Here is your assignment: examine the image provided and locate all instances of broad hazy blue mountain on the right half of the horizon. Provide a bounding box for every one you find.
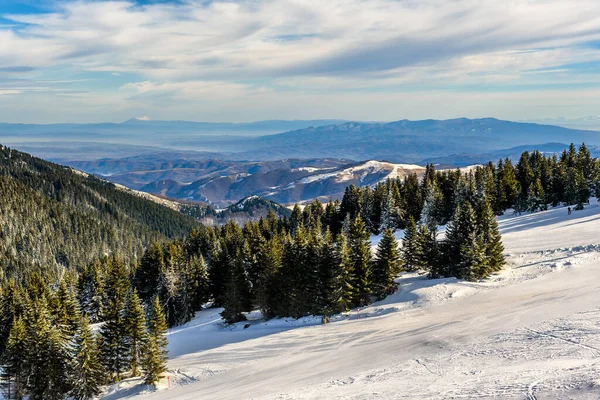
[237,118,600,163]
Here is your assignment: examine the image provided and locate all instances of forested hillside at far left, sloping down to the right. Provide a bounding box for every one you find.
[0,146,197,271]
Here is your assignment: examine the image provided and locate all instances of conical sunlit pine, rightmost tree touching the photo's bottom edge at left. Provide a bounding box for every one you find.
[71,316,105,400]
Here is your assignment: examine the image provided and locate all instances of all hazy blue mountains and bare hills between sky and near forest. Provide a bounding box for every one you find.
[0,117,600,208]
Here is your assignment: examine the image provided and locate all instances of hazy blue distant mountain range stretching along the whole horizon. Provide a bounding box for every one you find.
[0,118,600,163]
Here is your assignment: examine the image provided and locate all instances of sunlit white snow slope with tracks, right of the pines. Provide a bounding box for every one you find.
[104,200,600,400]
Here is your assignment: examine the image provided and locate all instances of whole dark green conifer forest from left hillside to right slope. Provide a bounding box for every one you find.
[0,145,600,399]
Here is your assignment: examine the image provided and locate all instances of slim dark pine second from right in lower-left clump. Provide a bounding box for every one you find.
[123,289,147,376]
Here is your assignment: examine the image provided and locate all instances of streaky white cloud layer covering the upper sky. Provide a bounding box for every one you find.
[0,0,600,119]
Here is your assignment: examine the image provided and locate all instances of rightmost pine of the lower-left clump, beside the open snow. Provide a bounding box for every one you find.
[142,297,168,386]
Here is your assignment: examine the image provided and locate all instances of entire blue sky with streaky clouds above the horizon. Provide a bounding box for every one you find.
[0,0,600,123]
